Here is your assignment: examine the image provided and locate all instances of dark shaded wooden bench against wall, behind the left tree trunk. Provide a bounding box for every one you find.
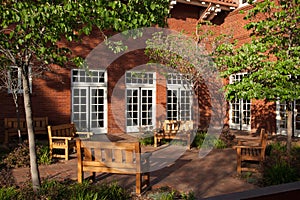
[4,117,48,144]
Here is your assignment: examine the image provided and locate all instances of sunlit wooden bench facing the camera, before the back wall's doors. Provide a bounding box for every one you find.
[154,120,194,149]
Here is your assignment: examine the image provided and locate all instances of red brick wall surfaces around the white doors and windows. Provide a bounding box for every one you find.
[0,3,276,141]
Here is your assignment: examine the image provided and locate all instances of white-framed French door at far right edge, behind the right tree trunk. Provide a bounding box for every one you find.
[276,100,300,137]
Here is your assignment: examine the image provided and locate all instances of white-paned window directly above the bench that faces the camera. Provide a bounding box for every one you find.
[167,73,193,121]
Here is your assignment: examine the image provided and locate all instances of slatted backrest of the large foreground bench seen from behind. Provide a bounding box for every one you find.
[76,139,141,174]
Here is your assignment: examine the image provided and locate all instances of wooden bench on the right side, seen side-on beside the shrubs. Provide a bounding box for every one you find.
[234,129,268,174]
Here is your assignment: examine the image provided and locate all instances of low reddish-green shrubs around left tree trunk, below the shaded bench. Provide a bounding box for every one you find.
[3,141,51,168]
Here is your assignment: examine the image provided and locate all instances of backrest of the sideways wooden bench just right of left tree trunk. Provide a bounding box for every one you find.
[48,124,76,137]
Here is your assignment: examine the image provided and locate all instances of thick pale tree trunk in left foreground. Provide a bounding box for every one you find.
[21,68,41,192]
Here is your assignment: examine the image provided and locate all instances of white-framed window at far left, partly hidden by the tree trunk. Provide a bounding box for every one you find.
[7,66,32,94]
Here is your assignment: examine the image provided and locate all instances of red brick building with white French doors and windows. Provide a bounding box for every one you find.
[0,0,300,141]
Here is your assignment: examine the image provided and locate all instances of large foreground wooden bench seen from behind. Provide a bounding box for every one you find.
[76,139,151,194]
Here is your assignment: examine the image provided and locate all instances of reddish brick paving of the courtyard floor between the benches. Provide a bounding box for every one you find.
[12,148,256,199]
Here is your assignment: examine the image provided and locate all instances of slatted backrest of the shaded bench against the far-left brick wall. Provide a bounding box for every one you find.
[4,117,48,130]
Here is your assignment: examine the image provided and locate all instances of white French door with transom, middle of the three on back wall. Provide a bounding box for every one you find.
[125,71,156,132]
